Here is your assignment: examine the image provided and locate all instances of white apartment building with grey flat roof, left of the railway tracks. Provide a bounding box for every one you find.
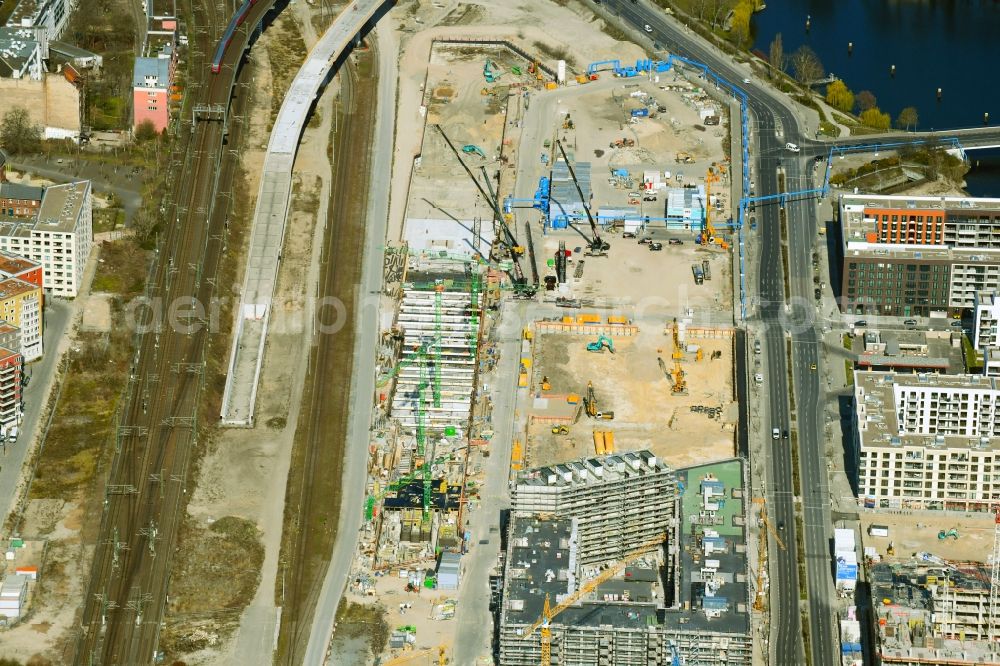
[0,181,94,298]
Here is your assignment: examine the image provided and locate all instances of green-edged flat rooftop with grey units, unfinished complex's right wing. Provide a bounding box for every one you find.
[664,460,750,634]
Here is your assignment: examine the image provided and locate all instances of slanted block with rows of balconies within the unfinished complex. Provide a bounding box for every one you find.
[512,451,677,564]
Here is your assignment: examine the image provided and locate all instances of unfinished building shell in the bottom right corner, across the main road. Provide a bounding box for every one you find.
[868,553,1000,666]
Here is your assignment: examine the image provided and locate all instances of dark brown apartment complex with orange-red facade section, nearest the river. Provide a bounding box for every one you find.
[840,194,1000,316]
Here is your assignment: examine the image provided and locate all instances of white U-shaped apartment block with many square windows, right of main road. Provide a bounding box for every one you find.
[854,371,1000,511]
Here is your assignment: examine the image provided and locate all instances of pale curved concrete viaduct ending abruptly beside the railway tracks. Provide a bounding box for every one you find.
[220,0,391,426]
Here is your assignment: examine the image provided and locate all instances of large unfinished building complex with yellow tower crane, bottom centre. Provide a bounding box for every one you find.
[497,451,751,666]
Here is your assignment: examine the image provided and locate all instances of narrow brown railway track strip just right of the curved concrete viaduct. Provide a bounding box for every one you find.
[278,45,376,664]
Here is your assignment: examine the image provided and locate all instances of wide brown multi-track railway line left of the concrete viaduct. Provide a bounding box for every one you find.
[74,1,272,665]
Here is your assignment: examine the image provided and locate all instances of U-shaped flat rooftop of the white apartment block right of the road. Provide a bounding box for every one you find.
[854,372,1000,450]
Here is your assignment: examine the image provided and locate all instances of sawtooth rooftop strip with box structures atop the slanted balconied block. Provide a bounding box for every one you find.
[516,451,670,488]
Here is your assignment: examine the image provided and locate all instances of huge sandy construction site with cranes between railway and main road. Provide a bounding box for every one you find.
[348,22,750,664]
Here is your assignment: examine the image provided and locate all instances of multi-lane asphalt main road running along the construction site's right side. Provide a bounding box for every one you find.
[608,1,839,666]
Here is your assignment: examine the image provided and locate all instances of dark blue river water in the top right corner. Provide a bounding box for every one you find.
[753,0,1000,196]
